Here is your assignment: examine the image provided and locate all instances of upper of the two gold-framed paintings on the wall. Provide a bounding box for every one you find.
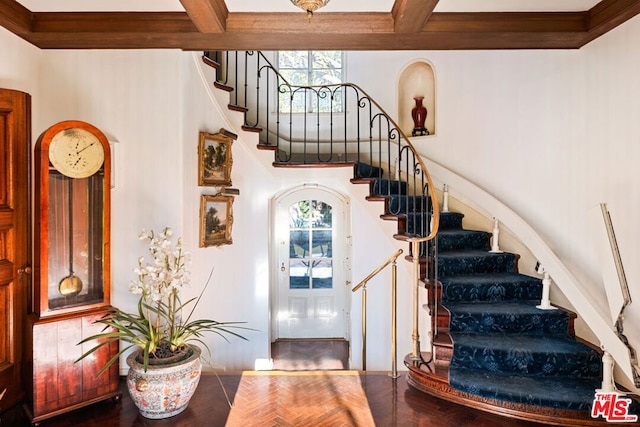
[198,129,237,187]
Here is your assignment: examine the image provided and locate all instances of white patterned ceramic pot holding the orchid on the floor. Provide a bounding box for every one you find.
[127,345,202,419]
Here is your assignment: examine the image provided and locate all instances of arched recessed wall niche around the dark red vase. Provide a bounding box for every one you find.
[398,60,436,136]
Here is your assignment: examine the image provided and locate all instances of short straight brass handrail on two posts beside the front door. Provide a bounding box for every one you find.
[351,249,402,378]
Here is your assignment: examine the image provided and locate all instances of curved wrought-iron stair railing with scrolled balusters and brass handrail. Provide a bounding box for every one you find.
[202,51,440,360]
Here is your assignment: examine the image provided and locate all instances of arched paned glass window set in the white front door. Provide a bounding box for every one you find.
[289,200,333,289]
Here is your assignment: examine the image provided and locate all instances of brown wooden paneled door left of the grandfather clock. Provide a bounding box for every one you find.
[0,89,31,409]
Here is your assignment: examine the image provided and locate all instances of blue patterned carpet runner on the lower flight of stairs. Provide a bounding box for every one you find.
[438,213,602,411]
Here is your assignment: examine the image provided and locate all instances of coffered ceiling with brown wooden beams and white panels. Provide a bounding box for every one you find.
[0,0,640,50]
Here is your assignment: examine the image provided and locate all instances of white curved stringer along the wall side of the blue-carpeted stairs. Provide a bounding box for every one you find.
[423,157,640,394]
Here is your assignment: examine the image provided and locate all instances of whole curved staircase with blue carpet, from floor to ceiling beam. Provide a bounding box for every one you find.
[198,53,637,426]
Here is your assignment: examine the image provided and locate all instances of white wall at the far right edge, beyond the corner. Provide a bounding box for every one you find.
[588,17,640,362]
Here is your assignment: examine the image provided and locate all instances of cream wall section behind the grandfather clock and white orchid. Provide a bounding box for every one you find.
[33,51,184,318]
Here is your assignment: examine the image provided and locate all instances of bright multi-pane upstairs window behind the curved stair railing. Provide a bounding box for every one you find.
[278,50,344,113]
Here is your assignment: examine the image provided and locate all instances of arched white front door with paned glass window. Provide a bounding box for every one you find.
[273,187,350,338]
